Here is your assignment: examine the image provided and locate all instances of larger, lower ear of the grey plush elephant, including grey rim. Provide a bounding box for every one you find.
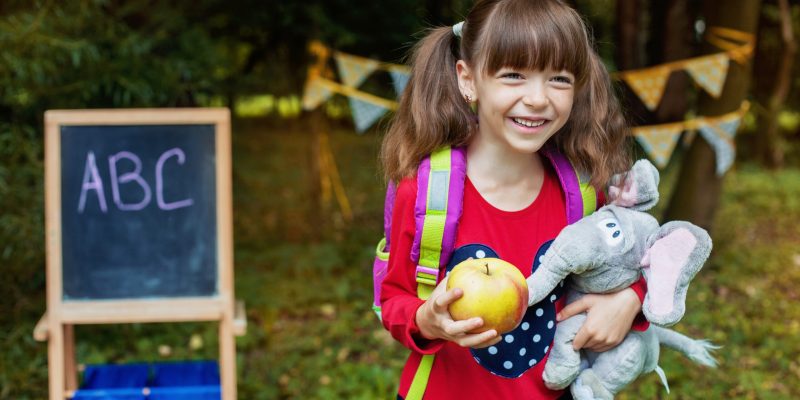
[641,221,711,326]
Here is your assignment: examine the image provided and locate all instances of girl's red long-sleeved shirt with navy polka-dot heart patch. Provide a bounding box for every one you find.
[381,165,643,400]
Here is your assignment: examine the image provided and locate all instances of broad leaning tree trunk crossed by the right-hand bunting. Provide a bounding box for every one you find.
[665,0,761,230]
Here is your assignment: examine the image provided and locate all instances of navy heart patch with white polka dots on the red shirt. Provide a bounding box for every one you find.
[447,240,564,378]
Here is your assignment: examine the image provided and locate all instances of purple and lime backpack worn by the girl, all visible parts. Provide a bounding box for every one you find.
[372,146,597,400]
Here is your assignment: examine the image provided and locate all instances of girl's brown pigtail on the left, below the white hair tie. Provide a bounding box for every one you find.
[380,27,475,182]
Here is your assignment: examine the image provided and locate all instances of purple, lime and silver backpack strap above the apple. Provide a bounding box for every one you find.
[411,147,467,300]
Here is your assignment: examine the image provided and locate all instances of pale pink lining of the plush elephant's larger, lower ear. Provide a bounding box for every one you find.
[642,228,697,315]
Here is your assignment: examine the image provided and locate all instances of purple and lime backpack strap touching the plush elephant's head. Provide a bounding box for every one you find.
[541,146,597,224]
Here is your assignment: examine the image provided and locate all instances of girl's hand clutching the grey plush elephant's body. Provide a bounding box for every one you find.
[556,288,642,352]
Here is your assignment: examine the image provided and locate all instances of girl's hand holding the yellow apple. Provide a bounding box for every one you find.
[416,278,501,348]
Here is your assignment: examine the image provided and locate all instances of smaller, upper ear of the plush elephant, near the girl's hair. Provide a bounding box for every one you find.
[608,159,659,211]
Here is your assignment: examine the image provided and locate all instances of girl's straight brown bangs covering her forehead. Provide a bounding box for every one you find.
[478,0,589,82]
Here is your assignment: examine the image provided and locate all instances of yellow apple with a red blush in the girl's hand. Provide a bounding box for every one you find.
[447,257,528,334]
